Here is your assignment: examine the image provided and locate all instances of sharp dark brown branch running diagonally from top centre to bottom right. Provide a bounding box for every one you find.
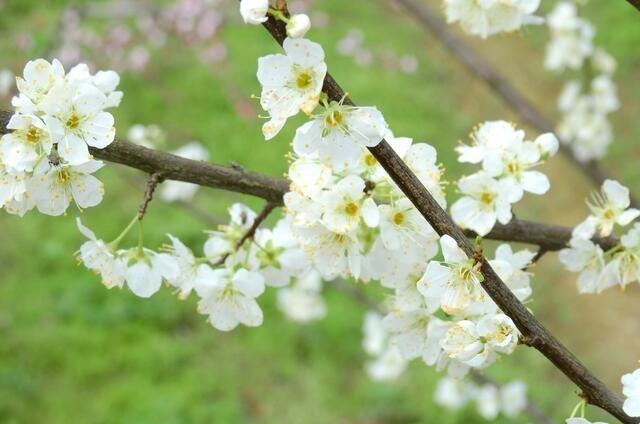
[263,9,637,424]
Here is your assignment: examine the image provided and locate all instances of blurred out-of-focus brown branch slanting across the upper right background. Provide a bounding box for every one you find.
[394,0,640,208]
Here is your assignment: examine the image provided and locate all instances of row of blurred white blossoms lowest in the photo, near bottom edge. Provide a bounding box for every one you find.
[434,377,527,421]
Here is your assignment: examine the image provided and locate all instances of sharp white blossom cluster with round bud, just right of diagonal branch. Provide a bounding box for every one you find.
[451,121,558,236]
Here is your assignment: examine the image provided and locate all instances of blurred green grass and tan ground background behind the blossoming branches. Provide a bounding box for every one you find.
[0,0,640,424]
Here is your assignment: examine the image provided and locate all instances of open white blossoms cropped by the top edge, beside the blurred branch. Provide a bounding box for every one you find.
[444,0,544,38]
